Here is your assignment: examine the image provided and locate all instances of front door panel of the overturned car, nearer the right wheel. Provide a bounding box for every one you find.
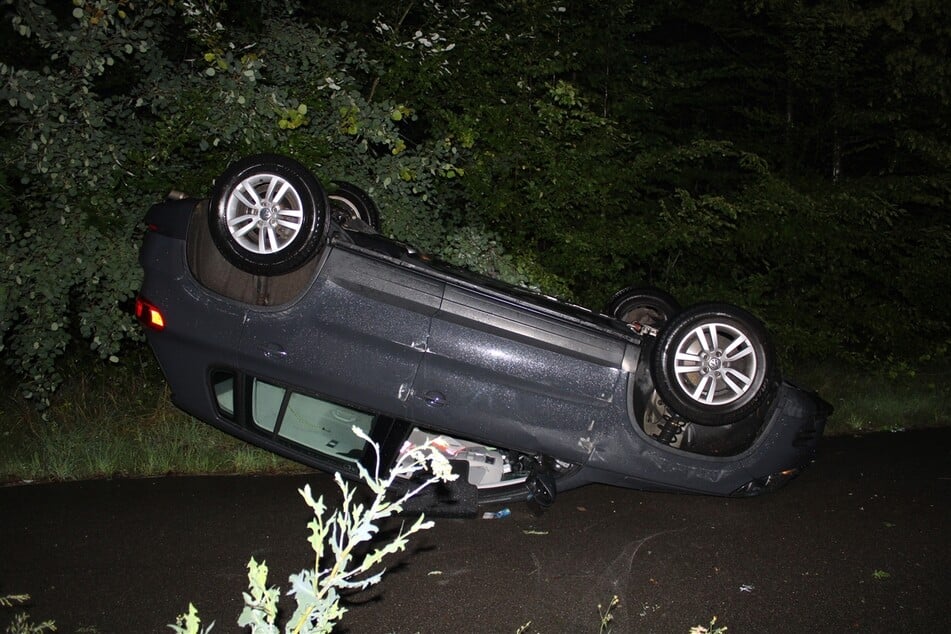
[411,283,626,461]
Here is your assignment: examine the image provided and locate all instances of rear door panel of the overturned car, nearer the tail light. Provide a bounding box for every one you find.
[241,245,442,418]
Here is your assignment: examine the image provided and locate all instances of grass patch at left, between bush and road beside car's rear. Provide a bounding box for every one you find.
[0,354,306,481]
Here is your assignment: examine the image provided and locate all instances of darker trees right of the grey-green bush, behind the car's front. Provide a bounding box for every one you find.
[358,0,951,366]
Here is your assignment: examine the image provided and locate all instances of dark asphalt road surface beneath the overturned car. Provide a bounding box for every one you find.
[0,430,951,634]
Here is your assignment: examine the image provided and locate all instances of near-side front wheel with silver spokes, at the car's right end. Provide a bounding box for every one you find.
[651,304,778,425]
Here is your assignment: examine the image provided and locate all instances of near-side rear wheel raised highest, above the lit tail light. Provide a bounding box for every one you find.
[208,154,328,275]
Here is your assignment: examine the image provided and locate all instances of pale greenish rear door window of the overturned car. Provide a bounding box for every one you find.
[251,379,374,463]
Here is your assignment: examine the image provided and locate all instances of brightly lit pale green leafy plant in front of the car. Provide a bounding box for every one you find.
[169,427,458,634]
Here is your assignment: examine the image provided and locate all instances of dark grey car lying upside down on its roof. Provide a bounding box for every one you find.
[136,155,831,504]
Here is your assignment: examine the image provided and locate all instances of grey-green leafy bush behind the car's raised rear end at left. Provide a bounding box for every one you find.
[0,0,476,405]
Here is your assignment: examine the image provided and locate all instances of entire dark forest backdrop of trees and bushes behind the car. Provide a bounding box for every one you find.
[0,0,951,402]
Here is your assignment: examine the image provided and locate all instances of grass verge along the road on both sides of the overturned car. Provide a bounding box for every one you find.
[0,352,951,482]
